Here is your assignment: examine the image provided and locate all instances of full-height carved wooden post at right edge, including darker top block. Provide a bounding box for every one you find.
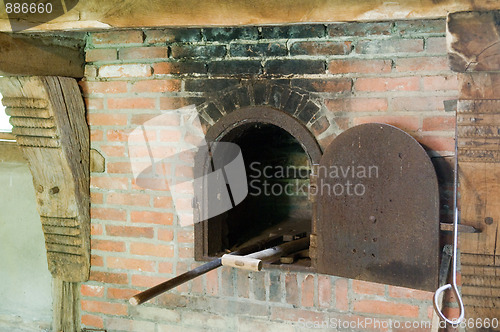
[447,11,500,322]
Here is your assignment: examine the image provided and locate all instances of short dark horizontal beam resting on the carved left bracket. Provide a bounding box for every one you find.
[0,33,84,78]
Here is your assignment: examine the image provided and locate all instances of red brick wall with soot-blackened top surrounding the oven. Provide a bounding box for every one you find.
[81,20,458,332]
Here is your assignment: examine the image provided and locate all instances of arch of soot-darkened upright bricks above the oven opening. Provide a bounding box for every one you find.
[197,81,330,139]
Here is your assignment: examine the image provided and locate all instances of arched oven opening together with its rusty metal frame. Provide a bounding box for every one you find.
[195,107,321,266]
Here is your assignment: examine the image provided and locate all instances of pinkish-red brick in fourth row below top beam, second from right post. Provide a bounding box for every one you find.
[354,77,420,91]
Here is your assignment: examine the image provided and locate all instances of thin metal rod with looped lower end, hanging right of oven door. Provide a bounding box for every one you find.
[433,117,465,325]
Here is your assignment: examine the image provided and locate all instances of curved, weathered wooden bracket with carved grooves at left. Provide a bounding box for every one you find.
[0,76,90,282]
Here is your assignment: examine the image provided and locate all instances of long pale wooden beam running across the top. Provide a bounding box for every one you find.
[0,0,500,31]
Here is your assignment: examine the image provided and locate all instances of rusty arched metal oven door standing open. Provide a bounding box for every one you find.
[311,123,439,291]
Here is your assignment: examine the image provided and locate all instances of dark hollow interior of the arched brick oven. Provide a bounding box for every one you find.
[214,123,312,255]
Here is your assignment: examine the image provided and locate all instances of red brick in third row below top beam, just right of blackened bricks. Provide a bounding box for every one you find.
[328,59,392,74]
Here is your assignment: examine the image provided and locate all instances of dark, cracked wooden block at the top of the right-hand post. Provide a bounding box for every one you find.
[447,11,500,72]
